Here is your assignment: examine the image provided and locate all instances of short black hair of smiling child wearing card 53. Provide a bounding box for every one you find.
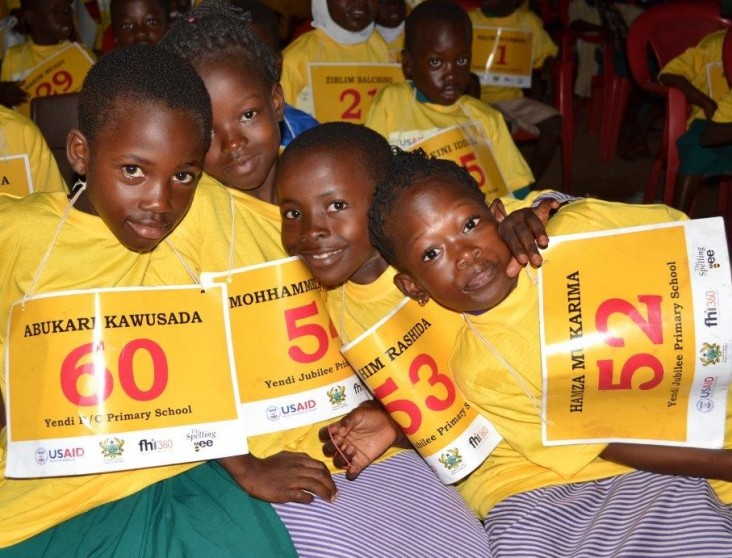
[277,122,391,187]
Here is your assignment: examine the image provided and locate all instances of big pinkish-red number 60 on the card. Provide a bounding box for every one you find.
[61,339,168,406]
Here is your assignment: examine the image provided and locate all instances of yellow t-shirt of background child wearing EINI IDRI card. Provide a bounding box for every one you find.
[366,82,534,197]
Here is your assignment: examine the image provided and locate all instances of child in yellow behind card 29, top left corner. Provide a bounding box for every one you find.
[0,0,94,106]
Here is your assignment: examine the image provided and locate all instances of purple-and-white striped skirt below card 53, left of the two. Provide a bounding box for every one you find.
[274,450,489,558]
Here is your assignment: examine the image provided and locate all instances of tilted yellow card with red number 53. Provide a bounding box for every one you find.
[341,299,501,484]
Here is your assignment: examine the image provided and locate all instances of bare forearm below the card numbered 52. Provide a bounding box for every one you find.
[600,443,732,482]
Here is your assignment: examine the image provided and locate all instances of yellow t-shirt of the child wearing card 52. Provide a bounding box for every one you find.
[450,199,716,517]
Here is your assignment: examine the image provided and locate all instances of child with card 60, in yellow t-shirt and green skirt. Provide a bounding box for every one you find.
[0,45,295,558]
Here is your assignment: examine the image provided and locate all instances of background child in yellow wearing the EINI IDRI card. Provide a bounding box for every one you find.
[366,0,534,197]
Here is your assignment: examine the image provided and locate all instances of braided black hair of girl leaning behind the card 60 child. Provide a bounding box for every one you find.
[158,0,280,87]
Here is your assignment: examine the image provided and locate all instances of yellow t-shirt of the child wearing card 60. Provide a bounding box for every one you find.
[0,192,197,547]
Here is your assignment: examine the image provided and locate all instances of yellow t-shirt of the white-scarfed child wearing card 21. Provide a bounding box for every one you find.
[280,29,394,116]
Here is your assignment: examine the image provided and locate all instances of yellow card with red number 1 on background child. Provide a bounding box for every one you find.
[470,25,534,88]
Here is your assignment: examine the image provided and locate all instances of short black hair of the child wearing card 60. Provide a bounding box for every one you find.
[79,45,213,149]
